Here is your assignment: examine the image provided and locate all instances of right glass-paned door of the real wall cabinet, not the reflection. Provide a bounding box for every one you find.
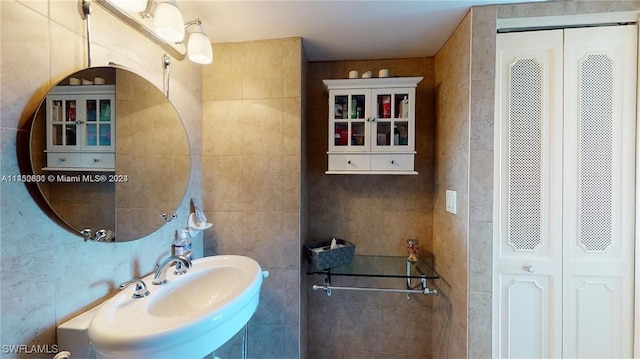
[372,89,412,151]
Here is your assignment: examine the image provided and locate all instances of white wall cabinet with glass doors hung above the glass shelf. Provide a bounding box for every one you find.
[323,77,422,174]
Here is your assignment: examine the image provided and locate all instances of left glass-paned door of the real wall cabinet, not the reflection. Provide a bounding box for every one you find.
[331,93,369,151]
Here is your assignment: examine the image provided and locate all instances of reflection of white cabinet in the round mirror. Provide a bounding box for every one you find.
[44,85,115,171]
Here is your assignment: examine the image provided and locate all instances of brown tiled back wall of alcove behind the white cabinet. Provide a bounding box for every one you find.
[306,58,435,358]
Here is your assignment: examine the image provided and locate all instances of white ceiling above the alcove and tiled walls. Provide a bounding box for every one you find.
[178,0,531,61]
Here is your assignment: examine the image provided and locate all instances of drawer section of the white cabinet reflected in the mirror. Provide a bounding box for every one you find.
[47,152,116,171]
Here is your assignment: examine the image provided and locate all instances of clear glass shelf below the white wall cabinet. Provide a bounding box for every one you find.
[307,255,440,279]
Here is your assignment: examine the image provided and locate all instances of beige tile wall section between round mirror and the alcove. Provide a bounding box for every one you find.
[202,38,306,358]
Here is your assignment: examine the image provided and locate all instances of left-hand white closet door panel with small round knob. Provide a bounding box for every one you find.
[494,30,563,358]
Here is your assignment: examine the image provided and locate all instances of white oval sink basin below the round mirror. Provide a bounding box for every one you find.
[88,255,263,359]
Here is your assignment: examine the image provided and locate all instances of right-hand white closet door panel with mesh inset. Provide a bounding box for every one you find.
[562,25,637,358]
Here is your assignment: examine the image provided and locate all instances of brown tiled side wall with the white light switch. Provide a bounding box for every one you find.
[433,14,471,358]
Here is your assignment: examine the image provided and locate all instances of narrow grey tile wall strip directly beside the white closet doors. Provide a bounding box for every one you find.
[468,6,496,358]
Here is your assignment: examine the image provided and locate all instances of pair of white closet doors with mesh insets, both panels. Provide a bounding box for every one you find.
[494,26,637,358]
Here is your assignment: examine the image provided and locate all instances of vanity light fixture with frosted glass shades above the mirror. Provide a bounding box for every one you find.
[96,0,213,65]
